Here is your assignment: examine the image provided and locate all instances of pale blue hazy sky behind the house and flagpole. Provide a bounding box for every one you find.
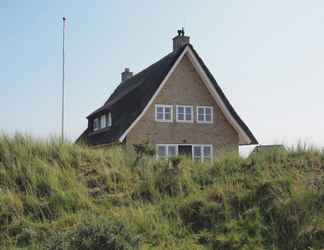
[0,0,324,154]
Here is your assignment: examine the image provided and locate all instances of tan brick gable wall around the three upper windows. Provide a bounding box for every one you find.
[126,56,239,156]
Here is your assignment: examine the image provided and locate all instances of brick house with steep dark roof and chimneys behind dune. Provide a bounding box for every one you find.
[78,30,257,161]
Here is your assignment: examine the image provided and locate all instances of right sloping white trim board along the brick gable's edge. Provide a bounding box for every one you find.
[188,49,251,144]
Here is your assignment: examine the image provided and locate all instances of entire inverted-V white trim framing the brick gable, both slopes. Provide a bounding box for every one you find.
[119,46,251,145]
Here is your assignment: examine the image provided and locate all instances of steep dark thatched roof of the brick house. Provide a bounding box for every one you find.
[78,44,257,145]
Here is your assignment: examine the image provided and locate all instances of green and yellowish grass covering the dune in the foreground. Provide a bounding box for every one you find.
[0,135,324,250]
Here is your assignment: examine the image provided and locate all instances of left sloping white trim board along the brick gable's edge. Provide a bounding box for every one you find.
[119,46,189,142]
